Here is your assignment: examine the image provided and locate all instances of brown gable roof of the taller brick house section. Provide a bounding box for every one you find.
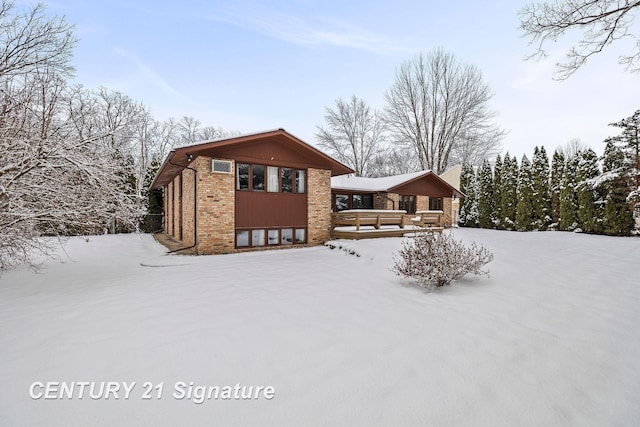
[151,129,353,190]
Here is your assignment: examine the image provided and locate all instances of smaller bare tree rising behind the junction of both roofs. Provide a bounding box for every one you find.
[316,95,385,176]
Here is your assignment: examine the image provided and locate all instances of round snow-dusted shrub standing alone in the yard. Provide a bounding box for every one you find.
[393,231,493,288]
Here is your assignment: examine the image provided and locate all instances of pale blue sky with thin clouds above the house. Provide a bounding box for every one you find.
[42,0,640,158]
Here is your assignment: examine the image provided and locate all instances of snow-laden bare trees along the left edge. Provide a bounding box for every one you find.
[0,2,152,269]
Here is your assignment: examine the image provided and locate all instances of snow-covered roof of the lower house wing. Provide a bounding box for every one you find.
[331,170,464,197]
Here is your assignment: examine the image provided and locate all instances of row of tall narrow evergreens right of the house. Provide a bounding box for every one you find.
[459,140,634,235]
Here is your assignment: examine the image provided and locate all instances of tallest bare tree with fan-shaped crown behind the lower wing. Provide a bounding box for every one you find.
[386,49,505,173]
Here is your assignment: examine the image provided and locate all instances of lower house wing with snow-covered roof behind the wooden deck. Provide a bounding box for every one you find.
[331,171,462,227]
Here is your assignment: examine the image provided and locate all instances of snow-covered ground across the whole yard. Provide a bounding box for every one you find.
[0,229,640,427]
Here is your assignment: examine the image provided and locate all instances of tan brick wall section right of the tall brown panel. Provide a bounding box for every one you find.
[307,168,331,245]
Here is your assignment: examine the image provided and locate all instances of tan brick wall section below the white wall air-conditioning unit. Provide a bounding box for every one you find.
[196,156,235,254]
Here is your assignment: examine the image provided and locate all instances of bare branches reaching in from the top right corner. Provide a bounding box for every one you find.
[519,0,640,80]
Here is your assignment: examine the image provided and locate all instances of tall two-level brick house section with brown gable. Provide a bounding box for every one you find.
[151,129,353,254]
